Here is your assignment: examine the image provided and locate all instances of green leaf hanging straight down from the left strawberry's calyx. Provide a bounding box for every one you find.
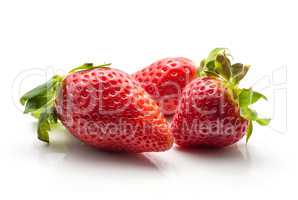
[37,106,57,143]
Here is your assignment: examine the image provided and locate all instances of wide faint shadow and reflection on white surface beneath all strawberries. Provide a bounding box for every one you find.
[22,122,277,182]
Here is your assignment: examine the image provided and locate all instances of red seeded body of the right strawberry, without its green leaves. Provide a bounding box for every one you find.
[171,77,248,147]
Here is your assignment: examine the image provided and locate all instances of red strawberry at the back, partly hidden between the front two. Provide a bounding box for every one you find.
[132,57,196,115]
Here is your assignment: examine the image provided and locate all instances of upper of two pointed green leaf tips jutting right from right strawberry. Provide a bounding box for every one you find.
[239,89,267,107]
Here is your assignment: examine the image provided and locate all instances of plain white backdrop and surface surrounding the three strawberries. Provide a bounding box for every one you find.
[0,0,298,200]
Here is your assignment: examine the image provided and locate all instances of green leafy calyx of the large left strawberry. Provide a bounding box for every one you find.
[20,63,111,143]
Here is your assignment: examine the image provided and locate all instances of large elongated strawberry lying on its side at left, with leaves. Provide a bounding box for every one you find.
[21,64,173,152]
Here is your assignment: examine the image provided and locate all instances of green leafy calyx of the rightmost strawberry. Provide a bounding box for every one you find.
[197,48,270,142]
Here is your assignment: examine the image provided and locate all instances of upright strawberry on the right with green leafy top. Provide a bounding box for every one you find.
[171,48,270,147]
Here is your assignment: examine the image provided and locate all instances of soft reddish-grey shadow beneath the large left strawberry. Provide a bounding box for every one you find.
[32,123,163,171]
